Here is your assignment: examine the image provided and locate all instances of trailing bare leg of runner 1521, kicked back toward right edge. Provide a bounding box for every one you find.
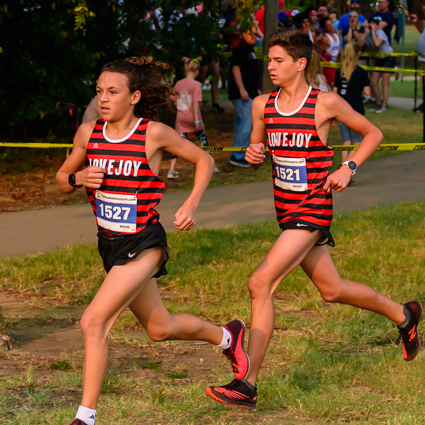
[301,246,405,325]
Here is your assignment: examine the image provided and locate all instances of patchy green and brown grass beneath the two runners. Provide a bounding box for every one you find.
[0,201,425,425]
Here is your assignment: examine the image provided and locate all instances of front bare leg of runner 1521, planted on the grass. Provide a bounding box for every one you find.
[246,229,322,385]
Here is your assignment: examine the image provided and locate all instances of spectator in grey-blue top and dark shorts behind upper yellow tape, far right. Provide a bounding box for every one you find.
[365,16,396,114]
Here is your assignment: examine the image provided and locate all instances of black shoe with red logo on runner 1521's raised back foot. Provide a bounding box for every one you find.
[397,301,423,362]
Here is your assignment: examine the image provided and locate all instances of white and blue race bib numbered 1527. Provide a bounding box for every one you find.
[96,190,137,233]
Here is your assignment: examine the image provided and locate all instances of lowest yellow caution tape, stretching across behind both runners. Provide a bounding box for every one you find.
[0,143,425,152]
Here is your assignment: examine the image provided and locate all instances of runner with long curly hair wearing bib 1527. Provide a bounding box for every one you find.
[56,58,249,425]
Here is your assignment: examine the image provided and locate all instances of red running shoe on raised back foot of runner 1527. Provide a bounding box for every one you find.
[223,320,249,380]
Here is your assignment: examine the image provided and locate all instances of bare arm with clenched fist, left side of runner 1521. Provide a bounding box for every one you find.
[245,94,269,170]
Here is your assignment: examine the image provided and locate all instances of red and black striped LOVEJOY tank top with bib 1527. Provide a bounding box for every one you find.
[87,118,165,236]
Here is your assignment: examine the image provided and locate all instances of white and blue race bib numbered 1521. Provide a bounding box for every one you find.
[273,155,308,192]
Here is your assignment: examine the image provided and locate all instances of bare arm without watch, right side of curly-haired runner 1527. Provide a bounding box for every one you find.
[146,121,214,230]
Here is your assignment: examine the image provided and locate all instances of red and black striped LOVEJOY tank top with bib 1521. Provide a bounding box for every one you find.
[264,87,334,229]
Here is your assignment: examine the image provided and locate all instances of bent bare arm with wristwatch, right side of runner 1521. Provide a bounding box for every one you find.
[316,93,384,192]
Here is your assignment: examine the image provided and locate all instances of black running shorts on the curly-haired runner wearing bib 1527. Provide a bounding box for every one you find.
[97,223,171,278]
